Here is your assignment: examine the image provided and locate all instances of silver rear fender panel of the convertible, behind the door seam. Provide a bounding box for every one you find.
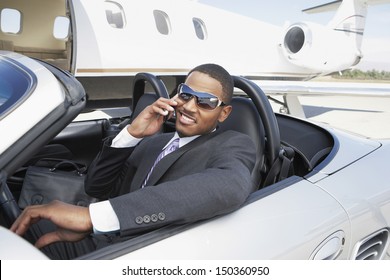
[317,141,390,258]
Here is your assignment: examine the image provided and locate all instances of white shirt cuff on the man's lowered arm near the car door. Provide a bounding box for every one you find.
[89,200,120,234]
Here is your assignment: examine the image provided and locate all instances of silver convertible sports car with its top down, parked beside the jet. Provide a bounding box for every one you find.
[0,52,390,260]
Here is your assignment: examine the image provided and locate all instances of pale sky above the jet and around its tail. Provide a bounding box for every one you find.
[198,0,390,71]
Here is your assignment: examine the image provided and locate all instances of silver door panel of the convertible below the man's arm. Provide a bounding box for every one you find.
[113,180,350,259]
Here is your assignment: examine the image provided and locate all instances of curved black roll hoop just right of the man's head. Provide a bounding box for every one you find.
[233,76,280,176]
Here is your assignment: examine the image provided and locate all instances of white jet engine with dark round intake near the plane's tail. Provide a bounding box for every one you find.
[280,22,362,73]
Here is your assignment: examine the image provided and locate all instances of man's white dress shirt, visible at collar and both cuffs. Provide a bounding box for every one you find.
[89,127,199,233]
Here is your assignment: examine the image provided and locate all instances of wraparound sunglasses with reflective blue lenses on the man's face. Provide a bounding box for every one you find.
[177,84,226,110]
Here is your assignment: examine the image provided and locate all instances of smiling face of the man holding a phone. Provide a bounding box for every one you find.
[175,72,232,137]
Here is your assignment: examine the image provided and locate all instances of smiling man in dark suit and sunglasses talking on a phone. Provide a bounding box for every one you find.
[11,64,255,257]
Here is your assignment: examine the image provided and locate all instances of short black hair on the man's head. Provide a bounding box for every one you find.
[187,63,234,104]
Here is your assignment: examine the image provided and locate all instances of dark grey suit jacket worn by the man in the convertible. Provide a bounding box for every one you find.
[86,130,255,236]
